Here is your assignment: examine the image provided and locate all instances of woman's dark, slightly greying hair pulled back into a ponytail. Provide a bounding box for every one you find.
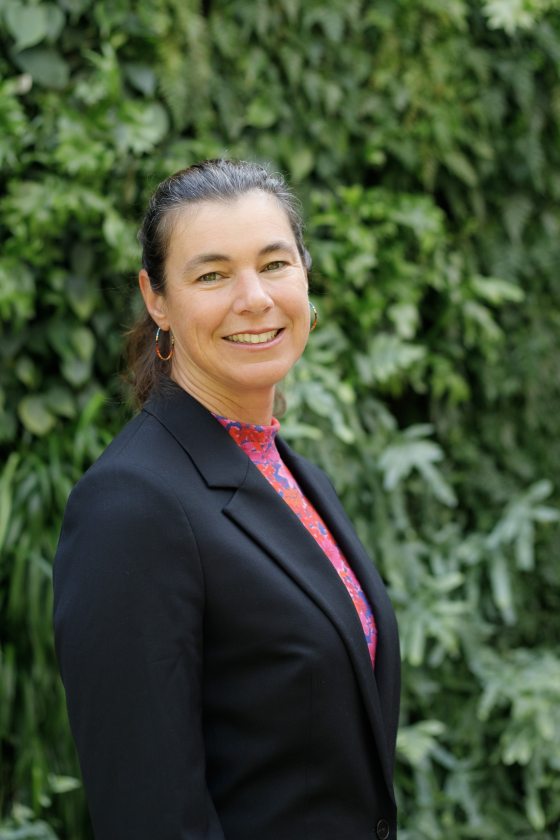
[127,159,311,406]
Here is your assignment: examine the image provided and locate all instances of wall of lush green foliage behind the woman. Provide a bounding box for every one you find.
[0,0,560,840]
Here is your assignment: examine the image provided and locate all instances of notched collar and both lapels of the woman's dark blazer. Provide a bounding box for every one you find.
[144,386,398,798]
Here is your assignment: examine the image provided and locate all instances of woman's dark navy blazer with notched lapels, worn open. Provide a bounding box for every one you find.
[54,387,400,840]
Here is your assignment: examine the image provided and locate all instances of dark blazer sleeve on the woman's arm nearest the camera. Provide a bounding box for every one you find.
[54,466,223,840]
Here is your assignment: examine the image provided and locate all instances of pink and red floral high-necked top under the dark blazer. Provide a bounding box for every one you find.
[214,414,377,665]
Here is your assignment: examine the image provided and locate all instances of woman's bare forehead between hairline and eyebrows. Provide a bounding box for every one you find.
[168,190,295,259]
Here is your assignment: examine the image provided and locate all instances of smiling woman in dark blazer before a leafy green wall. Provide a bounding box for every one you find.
[54,160,399,840]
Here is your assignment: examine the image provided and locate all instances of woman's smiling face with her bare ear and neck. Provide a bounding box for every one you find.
[140,191,309,423]
